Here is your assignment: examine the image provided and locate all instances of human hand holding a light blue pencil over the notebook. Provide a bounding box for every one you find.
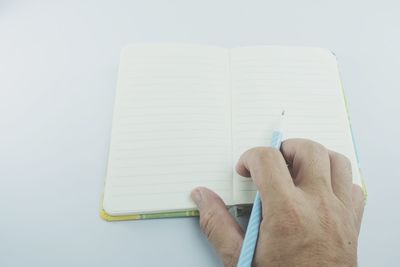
[191,139,364,267]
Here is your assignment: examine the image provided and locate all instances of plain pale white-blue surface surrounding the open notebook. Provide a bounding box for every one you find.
[0,0,400,267]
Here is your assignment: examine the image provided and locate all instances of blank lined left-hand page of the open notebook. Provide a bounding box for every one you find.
[103,44,233,215]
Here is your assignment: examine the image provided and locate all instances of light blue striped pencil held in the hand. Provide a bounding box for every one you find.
[237,110,285,267]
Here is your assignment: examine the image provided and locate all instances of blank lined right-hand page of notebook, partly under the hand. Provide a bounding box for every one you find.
[231,47,359,203]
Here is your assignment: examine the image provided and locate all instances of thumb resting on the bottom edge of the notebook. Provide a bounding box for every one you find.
[191,187,243,266]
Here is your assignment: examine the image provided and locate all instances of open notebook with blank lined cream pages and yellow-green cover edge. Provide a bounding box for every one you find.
[101,44,360,220]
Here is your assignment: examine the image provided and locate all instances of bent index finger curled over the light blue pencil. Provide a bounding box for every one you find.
[236,147,294,202]
